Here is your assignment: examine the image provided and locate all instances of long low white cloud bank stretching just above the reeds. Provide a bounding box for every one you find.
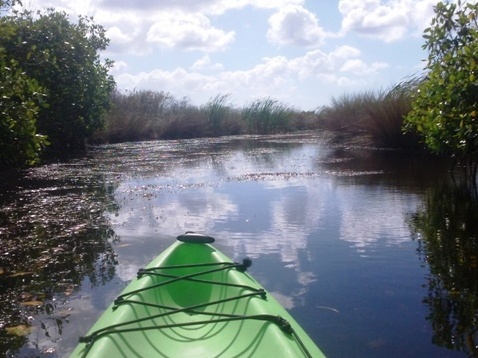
[115,46,387,103]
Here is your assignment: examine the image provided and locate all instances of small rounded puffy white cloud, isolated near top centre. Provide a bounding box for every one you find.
[267,5,327,46]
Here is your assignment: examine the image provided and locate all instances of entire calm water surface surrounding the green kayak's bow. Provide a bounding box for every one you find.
[0,134,478,357]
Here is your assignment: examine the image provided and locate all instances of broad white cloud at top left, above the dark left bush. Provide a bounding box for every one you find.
[22,0,235,55]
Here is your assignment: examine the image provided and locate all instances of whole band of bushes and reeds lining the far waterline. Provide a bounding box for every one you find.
[4,0,478,180]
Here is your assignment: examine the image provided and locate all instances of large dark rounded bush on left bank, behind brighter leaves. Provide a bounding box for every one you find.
[0,10,114,155]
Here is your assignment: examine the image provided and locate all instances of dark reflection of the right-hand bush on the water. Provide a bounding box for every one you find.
[411,185,478,357]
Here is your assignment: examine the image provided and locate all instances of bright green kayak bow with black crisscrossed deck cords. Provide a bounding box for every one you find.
[71,232,324,358]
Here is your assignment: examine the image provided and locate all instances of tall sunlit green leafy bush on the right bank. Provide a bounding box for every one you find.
[405,1,478,173]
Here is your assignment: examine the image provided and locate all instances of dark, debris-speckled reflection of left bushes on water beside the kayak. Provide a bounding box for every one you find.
[0,165,116,356]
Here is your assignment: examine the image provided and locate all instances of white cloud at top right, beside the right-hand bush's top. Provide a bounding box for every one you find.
[339,0,436,42]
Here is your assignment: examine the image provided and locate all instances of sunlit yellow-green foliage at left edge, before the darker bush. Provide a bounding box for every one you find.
[0,48,48,168]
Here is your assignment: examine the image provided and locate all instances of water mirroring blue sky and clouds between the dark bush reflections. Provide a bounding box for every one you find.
[2,134,467,358]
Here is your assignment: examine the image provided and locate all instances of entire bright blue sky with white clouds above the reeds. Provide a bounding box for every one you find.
[16,0,446,110]
